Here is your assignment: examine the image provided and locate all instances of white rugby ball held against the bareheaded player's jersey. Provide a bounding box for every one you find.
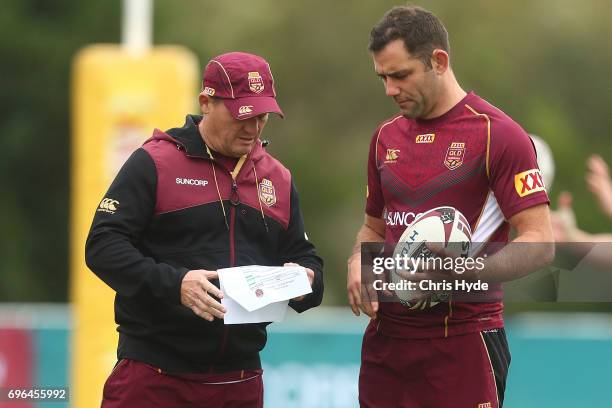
[390,207,472,309]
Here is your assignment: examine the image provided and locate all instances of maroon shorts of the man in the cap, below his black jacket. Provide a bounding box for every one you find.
[102,360,263,408]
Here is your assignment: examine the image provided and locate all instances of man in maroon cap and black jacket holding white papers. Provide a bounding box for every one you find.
[86,52,323,408]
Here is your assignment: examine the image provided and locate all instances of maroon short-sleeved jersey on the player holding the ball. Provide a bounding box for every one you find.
[366,93,548,338]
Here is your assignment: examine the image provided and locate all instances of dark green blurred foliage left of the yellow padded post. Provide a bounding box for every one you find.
[0,0,119,301]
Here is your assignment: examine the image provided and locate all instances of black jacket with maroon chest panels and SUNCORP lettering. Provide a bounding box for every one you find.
[85,116,323,373]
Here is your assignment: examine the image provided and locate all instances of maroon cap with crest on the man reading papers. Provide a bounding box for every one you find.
[202,52,283,120]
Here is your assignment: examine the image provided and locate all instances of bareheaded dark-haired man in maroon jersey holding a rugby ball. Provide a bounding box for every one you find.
[347,6,554,408]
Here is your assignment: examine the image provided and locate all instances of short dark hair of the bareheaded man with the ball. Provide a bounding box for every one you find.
[368,6,450,68]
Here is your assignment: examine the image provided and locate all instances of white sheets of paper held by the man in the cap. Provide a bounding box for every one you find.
[218,265,312,324]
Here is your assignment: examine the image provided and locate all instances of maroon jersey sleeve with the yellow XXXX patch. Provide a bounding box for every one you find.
[488,120,550,219]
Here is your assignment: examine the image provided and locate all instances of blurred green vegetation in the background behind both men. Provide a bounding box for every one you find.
[0,0,612,304]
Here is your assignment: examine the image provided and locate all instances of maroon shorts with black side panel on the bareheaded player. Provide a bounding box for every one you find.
[359,321,510,408]
